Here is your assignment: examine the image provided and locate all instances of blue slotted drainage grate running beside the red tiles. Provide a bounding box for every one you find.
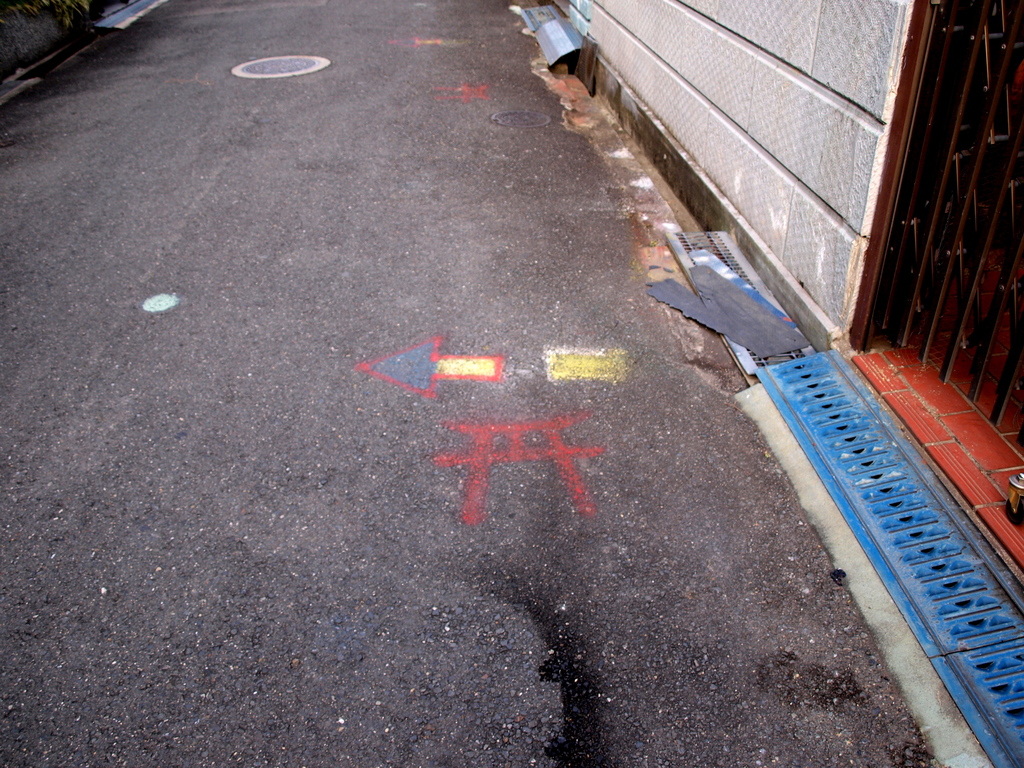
[758,352,1024,768]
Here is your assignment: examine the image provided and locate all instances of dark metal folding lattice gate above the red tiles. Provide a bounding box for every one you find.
[872,0,1024,443]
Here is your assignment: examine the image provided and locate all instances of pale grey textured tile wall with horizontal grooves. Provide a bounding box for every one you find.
[590,0,908,327]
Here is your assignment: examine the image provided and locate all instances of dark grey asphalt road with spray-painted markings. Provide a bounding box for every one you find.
[0,0,927,768]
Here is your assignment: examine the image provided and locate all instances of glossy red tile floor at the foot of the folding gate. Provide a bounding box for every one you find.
[853,348,1024,568]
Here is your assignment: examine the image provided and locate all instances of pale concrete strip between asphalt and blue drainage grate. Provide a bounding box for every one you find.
[735,384,991,768]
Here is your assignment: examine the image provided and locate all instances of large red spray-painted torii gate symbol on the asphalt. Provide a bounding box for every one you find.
[434,413,604,525]
